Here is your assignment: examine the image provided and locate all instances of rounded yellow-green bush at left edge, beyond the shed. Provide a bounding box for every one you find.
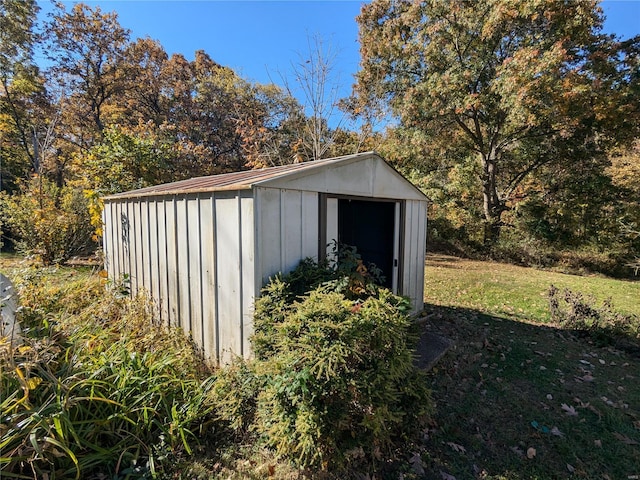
[0,176,94,265]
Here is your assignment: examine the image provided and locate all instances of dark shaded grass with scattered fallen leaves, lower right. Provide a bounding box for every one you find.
[416,305,640,480]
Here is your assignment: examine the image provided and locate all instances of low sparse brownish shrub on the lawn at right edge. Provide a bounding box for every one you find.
[548,285,640,348]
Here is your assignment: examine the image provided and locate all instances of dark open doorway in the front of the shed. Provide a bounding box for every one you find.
[338,198,395,288]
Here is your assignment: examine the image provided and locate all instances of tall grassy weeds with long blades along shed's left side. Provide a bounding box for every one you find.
[0,272,218,479]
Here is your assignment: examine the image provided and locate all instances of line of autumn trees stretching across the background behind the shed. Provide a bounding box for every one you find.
[0,0,640,274]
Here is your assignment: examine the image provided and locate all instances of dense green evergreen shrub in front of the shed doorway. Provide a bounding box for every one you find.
[248,260,431,470]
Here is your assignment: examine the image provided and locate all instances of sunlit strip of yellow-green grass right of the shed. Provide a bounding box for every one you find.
[425,255,640,322]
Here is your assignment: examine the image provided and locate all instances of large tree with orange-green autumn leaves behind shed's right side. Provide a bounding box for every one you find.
[353,0,640,245]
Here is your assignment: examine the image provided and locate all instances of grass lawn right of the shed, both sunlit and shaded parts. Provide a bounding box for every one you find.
[418,256,640,480]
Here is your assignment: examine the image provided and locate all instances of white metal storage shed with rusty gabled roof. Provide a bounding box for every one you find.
[103,152,427,362]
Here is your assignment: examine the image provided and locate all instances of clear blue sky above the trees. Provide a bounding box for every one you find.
[39,0,640,105]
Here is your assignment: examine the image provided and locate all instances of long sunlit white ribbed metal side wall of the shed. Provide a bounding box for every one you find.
[103,191,256,362]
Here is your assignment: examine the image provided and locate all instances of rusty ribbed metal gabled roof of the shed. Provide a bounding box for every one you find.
[104,152,427,200]
